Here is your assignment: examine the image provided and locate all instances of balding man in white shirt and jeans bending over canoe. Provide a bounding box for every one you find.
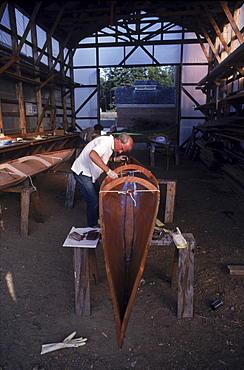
[71,133,133,227]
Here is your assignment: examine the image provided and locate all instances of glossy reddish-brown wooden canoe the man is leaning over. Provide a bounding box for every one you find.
[99,158,160,348]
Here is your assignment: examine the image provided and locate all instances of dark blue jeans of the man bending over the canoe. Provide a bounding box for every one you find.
[73,172,100,227]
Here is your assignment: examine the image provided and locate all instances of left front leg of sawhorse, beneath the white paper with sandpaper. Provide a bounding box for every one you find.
[74,247,91,316]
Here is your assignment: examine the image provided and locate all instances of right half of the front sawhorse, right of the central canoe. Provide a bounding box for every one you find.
[151,234,195,319]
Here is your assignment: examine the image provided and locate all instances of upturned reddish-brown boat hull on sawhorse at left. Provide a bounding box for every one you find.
[0,149,74,190]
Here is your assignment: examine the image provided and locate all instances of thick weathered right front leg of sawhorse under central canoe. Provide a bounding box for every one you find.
[177,236,195,319]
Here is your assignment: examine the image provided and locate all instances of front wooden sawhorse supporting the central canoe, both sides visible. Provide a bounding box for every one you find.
[63,234,195,319]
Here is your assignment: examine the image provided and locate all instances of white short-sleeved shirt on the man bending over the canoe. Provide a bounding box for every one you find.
[71,135,114,182]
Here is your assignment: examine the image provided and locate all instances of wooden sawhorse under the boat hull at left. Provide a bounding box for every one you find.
[3,179,43,236]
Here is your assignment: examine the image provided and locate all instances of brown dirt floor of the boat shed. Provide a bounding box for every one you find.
[0,150,244,370]
